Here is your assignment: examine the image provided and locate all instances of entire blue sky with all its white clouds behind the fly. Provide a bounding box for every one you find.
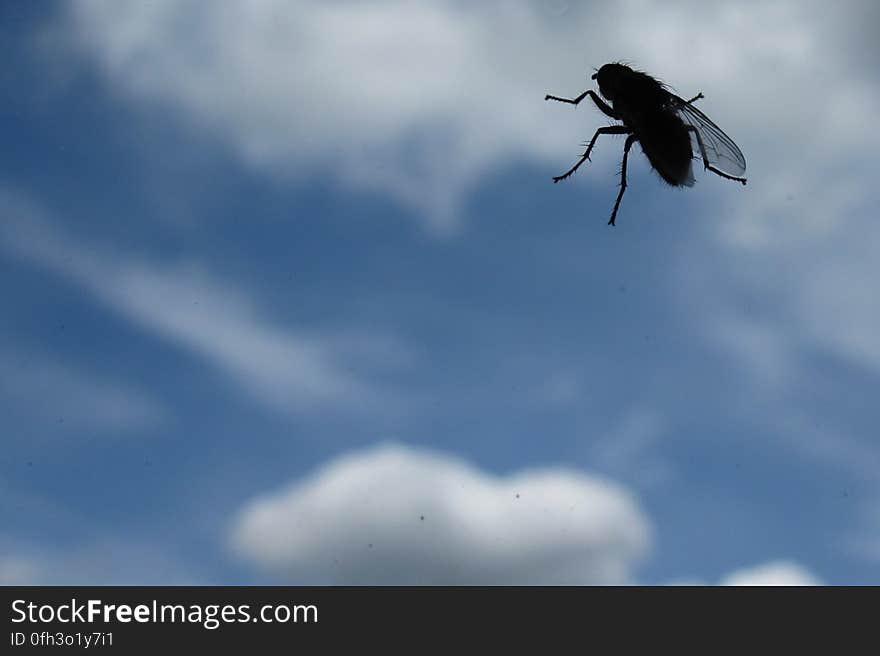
[0,0,880,584]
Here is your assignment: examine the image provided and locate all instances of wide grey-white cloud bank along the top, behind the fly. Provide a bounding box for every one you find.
[61,0,877,233]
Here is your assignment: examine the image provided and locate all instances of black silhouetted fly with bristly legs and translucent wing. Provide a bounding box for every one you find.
[544,64,746,225]
